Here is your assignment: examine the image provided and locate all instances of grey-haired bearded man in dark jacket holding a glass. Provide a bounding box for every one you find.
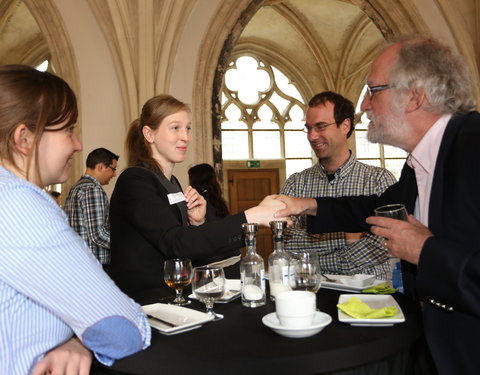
[279,37,480,375]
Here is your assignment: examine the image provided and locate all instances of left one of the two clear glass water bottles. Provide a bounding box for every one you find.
[240,223,266,307]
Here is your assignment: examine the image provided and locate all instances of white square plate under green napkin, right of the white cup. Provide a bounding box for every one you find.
[337,294,405,327]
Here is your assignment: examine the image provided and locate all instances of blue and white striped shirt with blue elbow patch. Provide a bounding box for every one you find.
[0,166,151,375]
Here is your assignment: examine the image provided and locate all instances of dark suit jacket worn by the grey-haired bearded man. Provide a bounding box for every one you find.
[308,112,480,374]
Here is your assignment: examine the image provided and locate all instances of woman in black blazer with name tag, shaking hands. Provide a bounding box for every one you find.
[110,95,285,297]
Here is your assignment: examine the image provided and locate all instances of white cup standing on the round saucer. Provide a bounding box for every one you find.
[275,290,317,328]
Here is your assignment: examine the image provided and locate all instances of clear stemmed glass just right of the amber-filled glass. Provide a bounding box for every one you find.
[192,266,225,320]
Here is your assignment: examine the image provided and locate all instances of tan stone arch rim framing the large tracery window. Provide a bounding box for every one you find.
[192,0,429,178]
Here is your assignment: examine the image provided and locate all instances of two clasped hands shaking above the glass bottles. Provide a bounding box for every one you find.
[245,195,317,226]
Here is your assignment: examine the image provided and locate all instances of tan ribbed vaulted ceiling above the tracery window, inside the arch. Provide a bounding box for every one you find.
[234,0,385,100]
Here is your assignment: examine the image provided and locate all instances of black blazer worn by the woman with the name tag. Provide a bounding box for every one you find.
[109,168,246,294]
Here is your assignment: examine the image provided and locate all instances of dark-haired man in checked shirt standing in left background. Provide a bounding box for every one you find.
[64,148,119,270]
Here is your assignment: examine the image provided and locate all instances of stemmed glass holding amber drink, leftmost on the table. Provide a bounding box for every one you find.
[163,259,192,306]
